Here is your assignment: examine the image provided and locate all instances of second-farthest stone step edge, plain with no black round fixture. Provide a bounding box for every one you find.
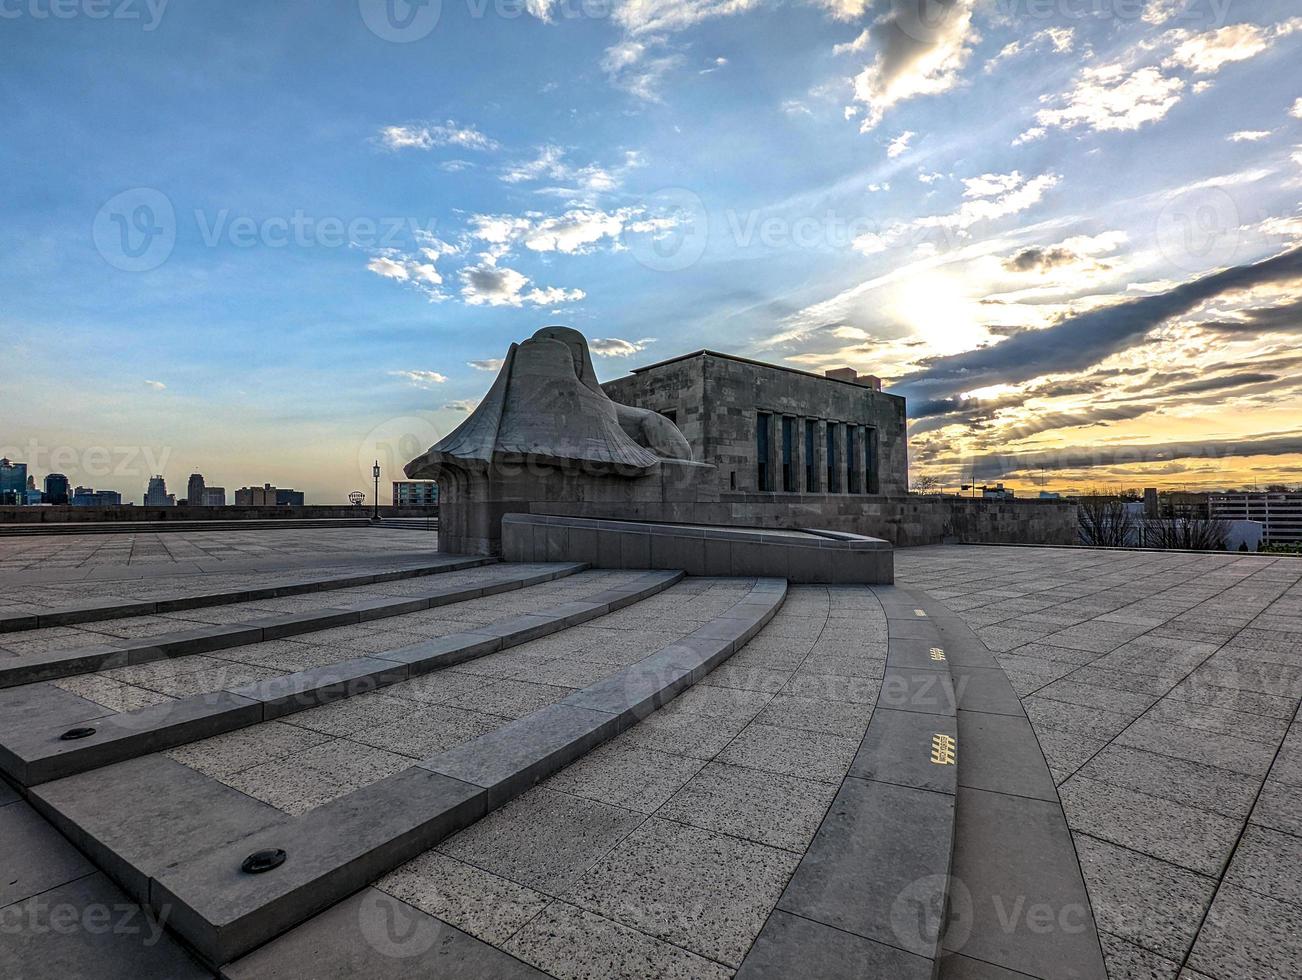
[0,562,587,687]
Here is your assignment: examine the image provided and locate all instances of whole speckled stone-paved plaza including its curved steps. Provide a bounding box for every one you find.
[0,527,1302,980]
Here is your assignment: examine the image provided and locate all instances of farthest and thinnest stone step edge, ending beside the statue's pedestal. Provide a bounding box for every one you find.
[0,558,495,633]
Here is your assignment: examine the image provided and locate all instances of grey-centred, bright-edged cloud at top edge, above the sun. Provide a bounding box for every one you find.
[837,0,980,133]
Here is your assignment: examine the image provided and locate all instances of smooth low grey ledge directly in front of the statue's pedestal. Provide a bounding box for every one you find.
[501,514,894,584]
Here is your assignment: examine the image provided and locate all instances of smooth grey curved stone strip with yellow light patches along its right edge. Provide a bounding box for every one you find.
[737,586,960,980]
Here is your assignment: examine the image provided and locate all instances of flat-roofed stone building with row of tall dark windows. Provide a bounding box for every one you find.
[602,350,909,495]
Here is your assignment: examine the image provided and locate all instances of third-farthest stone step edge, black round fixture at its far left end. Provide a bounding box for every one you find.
[0,571,682,786]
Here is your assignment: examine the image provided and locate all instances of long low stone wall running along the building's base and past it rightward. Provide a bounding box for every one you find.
[529,493,1077,547]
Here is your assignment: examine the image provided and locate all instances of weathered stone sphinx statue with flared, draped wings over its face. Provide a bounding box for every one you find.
[406,327,708,554]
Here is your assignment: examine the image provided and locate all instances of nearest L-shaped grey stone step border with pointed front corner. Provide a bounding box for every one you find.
[31,579,786,964]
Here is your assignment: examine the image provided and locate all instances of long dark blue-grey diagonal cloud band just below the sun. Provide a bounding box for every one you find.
[896,249,1302,393]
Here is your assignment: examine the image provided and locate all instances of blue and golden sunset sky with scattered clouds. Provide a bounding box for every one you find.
[0,0,1302,504]
